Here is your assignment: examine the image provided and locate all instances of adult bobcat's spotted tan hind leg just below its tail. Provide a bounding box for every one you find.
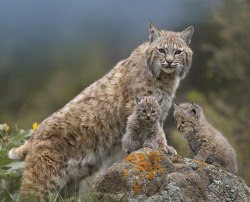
[20,148,66,201]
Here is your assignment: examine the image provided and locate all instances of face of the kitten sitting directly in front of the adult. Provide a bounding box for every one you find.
[135,96,162,122]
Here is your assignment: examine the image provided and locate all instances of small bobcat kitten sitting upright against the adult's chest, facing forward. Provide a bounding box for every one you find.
[122,96,176,154]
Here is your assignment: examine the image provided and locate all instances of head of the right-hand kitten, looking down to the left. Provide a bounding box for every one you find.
[174,103,199,134]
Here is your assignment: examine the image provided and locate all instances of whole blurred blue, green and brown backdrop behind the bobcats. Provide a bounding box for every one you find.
[0,0,250,185]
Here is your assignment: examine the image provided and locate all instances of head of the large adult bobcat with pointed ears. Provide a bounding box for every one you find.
[148,21,193,78]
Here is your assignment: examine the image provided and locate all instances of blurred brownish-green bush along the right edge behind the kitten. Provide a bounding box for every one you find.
[202,0,250,184]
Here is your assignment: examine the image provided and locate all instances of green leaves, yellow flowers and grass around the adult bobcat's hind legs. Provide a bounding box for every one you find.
[0,122,98,202]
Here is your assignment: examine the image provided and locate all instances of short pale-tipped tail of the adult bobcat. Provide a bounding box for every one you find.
[8,141,30,160]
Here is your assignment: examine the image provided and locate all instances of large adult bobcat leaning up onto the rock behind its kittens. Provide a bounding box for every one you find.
[9,22,194,200]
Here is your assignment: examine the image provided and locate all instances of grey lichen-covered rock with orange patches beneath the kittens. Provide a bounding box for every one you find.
[94,148,250,202]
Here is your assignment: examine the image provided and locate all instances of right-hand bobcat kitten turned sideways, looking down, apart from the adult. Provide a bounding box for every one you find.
[174,103,238,174]
